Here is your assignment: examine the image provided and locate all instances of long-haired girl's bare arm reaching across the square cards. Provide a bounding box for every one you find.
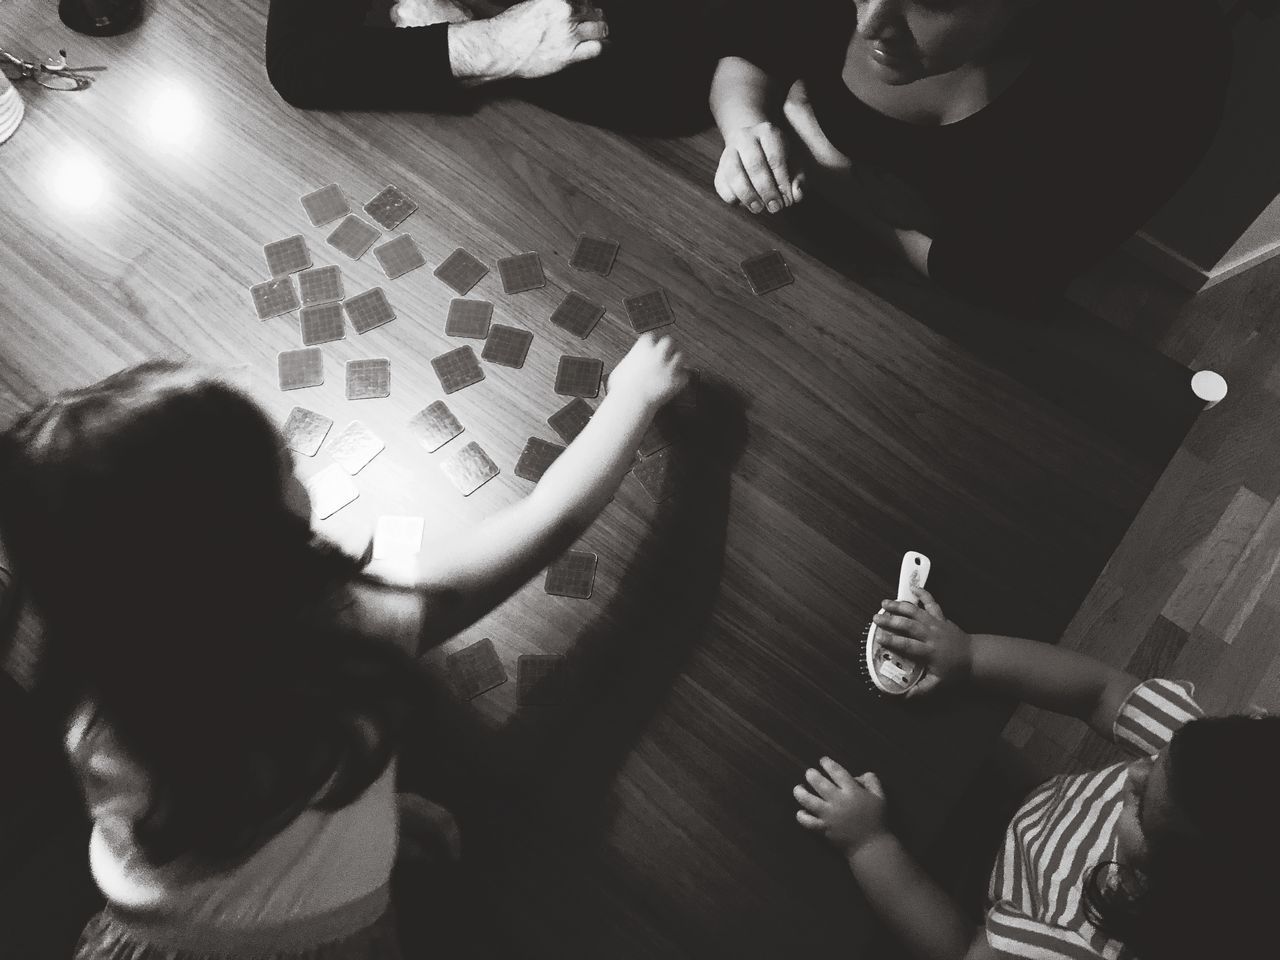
[417,334,687,652]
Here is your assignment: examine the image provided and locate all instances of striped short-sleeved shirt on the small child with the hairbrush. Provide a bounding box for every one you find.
[987,680,1203,960]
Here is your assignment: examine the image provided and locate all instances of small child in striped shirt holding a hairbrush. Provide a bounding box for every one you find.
[794,590,1280,960]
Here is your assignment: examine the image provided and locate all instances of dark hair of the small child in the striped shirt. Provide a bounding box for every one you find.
[1083,717,1280,960]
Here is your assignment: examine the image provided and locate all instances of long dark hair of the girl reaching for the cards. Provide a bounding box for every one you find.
[0,361,422,868]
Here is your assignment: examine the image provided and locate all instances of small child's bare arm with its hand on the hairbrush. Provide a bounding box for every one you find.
[876,590,1138,739]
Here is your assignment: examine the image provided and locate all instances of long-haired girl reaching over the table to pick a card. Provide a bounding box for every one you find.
[0,335,686,960]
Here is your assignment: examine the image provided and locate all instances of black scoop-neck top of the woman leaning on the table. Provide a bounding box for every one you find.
[723,0,1230,303]
